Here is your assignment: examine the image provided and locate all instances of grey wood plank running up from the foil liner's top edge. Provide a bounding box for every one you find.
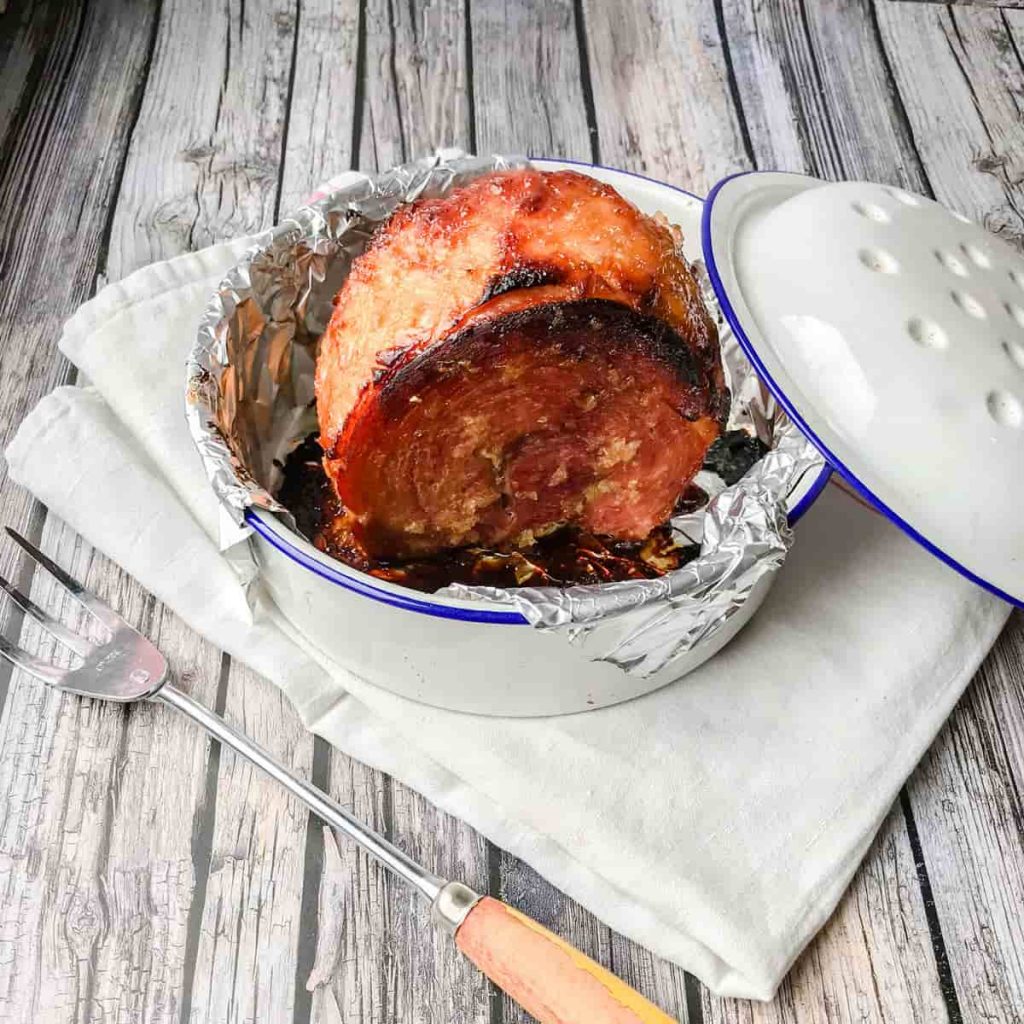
[358,0,473,171]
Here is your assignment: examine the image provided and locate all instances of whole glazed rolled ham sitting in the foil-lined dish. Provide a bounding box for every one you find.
[316,170,728,558]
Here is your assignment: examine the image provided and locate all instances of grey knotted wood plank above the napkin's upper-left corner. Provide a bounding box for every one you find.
[106,0,295,281]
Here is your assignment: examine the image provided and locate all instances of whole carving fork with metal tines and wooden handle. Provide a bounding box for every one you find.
[0,526,675,1024]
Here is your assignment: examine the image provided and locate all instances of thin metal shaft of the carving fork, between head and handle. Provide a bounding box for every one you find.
[152,683,444,902]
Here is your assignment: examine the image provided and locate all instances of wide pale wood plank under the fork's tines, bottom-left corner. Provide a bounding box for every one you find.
[0,517,220,1024]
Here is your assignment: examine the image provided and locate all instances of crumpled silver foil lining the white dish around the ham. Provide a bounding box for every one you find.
[185,151,822,677]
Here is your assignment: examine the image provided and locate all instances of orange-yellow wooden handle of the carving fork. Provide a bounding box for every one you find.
[455,896,676,1024]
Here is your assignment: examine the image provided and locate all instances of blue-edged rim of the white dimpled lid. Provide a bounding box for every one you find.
[700,171,1024,608]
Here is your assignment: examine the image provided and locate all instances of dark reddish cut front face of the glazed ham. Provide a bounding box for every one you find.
[333,299,719,558]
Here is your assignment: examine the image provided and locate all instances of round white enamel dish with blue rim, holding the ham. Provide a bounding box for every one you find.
[246,160,830,717]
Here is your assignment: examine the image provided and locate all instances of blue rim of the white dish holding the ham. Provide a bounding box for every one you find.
[245,157,831,626]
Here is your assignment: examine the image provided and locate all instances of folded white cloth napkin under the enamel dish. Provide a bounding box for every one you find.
[7,230,1008,998]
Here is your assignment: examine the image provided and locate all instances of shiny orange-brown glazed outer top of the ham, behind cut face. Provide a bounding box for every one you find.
[316,170,724,452]
